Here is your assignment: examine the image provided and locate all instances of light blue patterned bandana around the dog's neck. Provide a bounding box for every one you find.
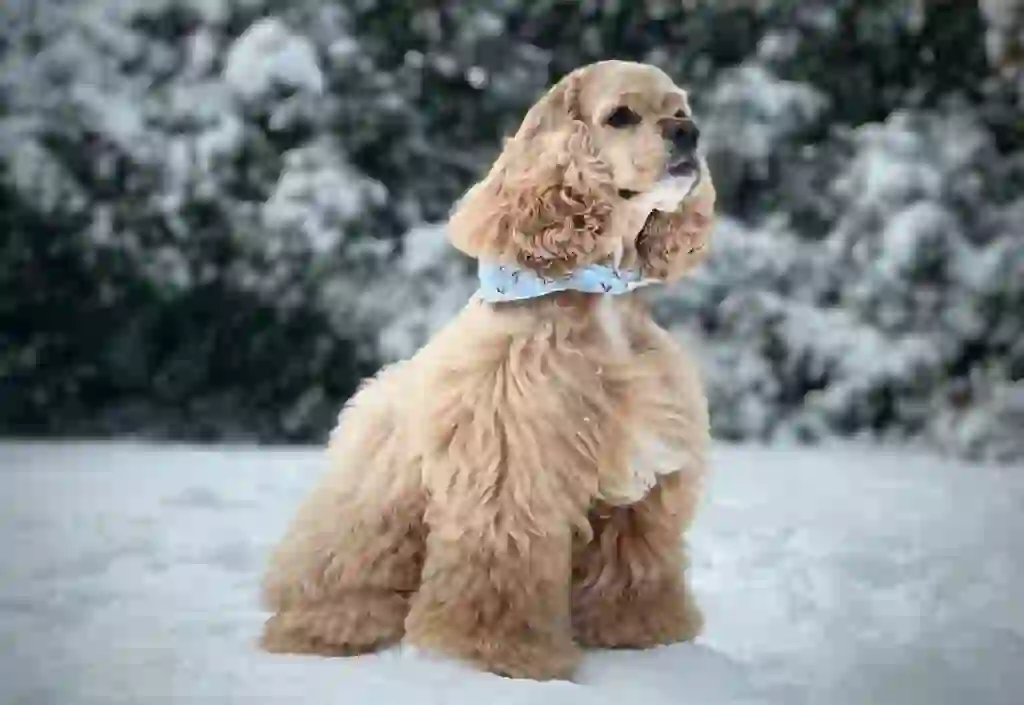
[476,262,659,303]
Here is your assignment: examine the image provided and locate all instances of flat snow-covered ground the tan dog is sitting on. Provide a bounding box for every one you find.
[0,444,1024,705]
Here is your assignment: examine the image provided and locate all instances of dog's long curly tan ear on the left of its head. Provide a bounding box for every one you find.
[449,70,615,276]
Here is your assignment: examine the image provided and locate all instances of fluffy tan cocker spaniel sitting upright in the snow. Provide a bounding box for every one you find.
[263,61,715,678]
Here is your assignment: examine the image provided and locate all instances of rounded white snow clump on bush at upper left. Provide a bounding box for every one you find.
[224,17,324,99]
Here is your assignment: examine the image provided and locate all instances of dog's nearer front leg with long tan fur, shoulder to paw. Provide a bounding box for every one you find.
[406,368,596,679]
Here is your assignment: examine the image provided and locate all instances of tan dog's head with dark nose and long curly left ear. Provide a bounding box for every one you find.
[449,61,702,275]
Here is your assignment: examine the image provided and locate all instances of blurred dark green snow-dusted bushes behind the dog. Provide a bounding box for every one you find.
[0,0,1024,459]
